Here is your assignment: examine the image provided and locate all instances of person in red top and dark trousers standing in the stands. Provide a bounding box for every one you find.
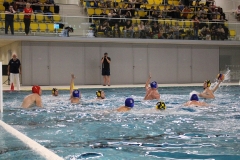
[23,3,33,36]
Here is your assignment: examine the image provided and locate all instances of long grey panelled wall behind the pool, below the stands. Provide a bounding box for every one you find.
[22,42,219,85]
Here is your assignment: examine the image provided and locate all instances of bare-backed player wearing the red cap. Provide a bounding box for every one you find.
[21,86,42,108]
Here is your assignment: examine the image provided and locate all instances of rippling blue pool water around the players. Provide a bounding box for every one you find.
[0,86,240,160]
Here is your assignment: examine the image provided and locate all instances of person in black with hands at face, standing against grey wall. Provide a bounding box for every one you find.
[101,53,111,86]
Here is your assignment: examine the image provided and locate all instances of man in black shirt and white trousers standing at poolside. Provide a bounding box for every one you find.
[8,53,22,90]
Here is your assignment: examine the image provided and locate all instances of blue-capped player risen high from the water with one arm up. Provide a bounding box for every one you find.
[144,74,160,100]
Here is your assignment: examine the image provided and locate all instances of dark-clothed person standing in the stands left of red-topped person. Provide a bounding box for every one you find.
[5,5,16,35]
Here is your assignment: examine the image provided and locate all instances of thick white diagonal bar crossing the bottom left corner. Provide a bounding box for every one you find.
[0,120,63,160]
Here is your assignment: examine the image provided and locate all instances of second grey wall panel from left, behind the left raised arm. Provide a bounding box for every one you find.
[49,42,85,85]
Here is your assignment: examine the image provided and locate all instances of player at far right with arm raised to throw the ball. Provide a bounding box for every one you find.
[198,80,222,99]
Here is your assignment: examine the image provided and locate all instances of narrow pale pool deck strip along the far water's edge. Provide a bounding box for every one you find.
[3,82,240,91]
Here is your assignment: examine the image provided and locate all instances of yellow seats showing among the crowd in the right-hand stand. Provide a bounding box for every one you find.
[81,0,235,37]
